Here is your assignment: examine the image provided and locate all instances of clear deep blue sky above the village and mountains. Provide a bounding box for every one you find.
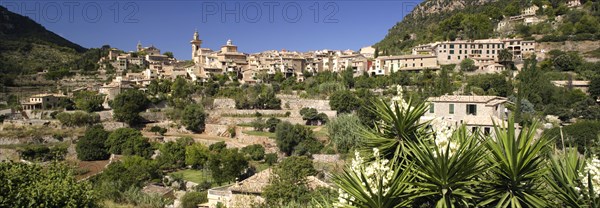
[0,0,421,60]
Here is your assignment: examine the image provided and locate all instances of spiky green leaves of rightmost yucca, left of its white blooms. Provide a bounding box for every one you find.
[544,149,596,207]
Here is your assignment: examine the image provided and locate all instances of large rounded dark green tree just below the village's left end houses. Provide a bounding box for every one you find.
[110,90,149,124]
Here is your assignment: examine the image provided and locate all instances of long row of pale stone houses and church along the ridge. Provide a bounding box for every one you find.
[101,25,552,91]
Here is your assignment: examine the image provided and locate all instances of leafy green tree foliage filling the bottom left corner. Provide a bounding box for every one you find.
[0,162,100,207]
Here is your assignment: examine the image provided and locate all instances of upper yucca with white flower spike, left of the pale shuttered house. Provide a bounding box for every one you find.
[359,96,429,159]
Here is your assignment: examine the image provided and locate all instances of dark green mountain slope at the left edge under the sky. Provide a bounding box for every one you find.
[0,6,93,85]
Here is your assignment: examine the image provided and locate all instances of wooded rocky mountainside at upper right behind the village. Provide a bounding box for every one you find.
[375,0,600,55]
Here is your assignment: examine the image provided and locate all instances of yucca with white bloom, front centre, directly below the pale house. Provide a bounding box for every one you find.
[409,126,487,207]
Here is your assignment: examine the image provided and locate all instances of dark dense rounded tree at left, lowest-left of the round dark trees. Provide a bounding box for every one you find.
[75,125,110,161]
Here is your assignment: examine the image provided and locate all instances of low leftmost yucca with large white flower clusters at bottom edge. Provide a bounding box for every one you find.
[333,149,412,208]
